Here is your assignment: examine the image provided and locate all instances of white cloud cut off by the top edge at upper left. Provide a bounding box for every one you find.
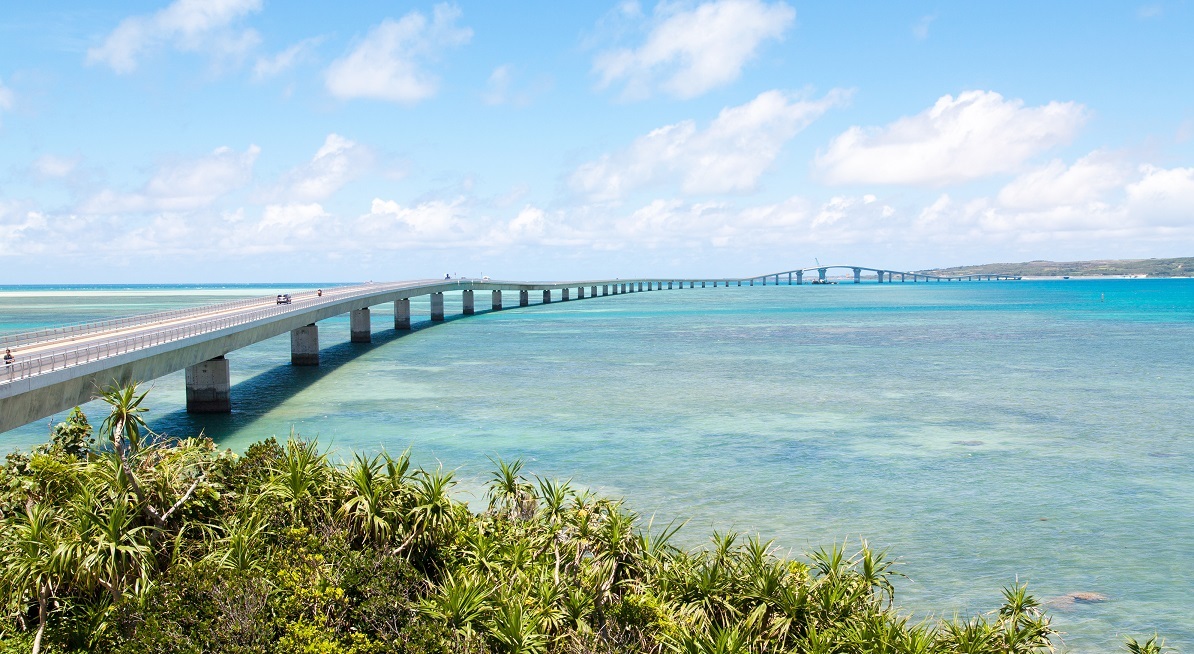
[87,0,261,73]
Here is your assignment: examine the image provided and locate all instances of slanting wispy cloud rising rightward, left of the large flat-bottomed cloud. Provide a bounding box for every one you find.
[570,90,849,200]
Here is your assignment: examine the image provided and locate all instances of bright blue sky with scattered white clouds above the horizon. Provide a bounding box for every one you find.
[0,0,1194,285]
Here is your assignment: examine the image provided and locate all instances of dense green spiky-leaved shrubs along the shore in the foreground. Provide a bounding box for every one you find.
[0,387,1163,654]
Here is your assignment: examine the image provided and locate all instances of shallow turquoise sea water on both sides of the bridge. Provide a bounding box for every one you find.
[0,279,1194,653]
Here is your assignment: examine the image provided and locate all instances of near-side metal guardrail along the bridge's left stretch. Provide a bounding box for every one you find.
[0,282,411,383]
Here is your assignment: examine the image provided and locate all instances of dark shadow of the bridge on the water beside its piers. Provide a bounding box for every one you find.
[150,311,477,445]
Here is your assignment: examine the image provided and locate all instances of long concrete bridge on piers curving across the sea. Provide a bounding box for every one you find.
[0,266,1018,432]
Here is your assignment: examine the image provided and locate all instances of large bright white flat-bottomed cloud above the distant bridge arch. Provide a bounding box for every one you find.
[816,91,1085,186]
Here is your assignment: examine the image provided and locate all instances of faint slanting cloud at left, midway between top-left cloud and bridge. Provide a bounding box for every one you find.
[82,146,261,214]
